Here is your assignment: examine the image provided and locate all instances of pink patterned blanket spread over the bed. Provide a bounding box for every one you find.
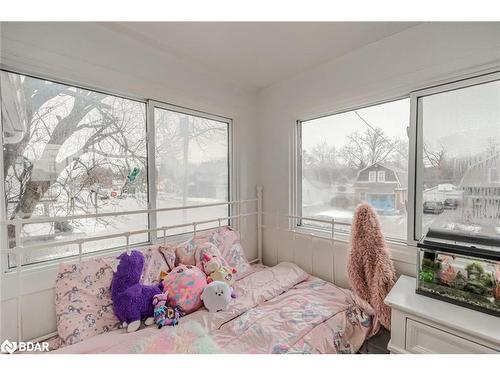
[53,263,374,353]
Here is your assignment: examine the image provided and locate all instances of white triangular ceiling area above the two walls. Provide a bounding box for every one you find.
[101,22,418,89]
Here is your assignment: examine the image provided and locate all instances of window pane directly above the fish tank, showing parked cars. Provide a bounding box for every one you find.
[418,81,500,235]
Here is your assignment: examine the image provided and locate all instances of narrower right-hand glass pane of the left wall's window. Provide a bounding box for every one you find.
[154,108,229,236]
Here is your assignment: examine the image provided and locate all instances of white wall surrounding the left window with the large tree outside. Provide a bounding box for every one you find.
[0,23,257,341]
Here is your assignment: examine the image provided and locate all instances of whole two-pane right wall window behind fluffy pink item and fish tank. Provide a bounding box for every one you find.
[297,72,500,245]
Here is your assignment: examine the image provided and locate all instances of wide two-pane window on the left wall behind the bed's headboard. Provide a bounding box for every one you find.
[0,71,231,267]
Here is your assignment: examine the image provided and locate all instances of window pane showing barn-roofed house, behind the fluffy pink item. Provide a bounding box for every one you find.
[301,99,410,239]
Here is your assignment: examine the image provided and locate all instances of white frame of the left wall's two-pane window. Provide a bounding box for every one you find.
[0,70,234,270]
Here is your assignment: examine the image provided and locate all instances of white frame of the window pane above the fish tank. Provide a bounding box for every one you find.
[408,72,500,245]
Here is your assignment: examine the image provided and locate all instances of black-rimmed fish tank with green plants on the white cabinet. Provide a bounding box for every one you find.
[416,229,500,316]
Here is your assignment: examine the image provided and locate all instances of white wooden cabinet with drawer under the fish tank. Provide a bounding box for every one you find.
[385,276,500,354]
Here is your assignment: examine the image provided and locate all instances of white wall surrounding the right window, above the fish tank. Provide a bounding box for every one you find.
[258,23,500,286]
